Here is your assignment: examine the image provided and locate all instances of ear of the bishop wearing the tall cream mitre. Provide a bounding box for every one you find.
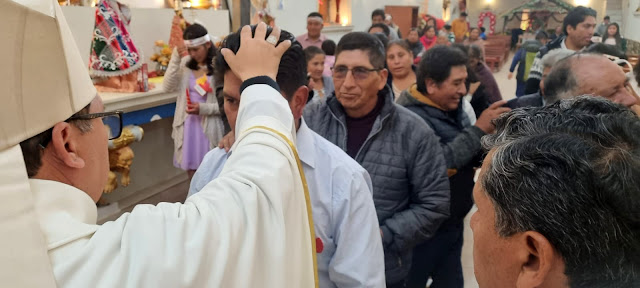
[51,122,85,169]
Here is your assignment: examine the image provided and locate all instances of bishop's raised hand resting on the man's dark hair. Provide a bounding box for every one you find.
[220,22,291,81]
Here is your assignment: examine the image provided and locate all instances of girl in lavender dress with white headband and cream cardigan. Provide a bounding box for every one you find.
[163,24,224,178]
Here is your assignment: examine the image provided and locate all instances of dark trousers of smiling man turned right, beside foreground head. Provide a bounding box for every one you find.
[407,220,464,288]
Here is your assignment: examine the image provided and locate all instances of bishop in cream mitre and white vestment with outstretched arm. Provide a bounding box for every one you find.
[0,0,318,288]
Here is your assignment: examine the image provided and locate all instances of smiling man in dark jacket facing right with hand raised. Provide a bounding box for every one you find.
[398,46,510,288]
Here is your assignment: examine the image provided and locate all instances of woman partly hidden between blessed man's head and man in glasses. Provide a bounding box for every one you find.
[304,46,334,101]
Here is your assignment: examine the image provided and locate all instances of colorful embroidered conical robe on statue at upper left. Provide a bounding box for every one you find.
[89,0,142,77]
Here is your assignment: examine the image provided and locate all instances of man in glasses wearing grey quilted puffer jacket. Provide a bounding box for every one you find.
[304,32,449,288]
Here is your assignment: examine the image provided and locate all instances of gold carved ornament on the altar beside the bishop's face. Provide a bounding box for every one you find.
[98,126,144,205]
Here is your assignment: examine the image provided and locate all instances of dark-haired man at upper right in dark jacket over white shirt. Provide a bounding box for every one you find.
[524,6,596,94]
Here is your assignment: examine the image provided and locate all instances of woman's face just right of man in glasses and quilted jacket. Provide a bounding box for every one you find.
[387,40,416,100]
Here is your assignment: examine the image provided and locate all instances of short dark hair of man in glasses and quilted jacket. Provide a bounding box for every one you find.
[336,32,386,69]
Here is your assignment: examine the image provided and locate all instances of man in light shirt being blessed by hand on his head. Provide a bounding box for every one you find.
[188,26,385,287]
